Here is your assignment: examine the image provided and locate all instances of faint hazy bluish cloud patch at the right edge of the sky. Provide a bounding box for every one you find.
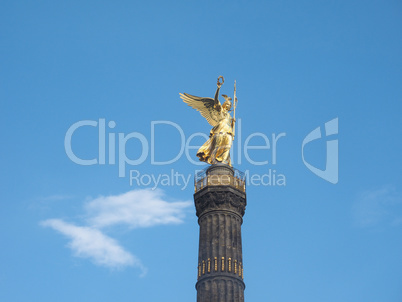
[353,186,402,227]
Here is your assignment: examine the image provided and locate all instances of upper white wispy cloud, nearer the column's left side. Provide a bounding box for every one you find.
[85,189,191,228]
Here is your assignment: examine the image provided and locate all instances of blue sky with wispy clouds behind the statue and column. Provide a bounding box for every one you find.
[0,0,402,302]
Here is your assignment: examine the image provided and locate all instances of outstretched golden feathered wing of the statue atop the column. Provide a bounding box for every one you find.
[180,93,219,127]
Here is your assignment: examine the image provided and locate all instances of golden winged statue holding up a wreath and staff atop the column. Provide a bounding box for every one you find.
[180,76,237,166]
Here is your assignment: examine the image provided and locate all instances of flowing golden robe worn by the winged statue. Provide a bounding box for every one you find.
[197,105,233,166]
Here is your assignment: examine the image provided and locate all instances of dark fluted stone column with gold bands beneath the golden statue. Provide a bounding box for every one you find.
[194,164,246,302]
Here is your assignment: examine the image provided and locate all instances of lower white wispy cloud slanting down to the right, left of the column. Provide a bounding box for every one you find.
[41,219,145,274]
